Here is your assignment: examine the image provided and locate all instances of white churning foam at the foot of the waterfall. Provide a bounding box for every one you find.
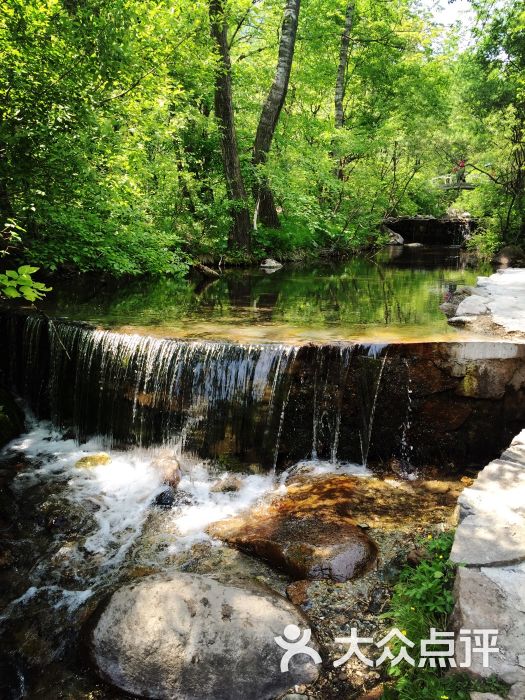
[2,423,372,584]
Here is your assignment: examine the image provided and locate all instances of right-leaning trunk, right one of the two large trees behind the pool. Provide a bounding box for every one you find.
[253,0,301,228]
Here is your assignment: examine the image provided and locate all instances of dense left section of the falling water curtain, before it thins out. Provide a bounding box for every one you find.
[3,316,296,468]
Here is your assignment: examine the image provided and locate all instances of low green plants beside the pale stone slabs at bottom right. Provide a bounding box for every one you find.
[383,532,507,700]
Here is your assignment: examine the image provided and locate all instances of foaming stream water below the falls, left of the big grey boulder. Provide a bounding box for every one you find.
[0,420,370,700]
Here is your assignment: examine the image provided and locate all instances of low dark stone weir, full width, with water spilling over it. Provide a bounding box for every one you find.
[0,315,525,469]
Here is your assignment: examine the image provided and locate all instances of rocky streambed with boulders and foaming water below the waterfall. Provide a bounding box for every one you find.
[0,424,471,698]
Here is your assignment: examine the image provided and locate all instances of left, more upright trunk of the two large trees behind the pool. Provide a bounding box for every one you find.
[210,0,251,253]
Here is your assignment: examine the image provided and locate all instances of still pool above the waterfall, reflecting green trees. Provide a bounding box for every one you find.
[44,246,490,342]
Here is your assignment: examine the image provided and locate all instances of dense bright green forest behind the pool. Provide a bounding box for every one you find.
[0,0,525,275]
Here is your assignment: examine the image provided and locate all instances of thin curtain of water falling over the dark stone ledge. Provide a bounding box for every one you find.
[0,314,402,469]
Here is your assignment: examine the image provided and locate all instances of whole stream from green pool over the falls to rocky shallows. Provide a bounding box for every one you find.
[0,249,523,700]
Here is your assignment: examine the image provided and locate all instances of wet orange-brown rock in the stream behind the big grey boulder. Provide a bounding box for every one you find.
[209,477,377,581]
